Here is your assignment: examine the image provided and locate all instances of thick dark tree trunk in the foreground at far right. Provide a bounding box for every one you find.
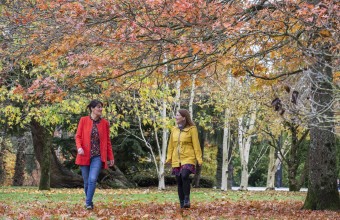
[303,54,340,210]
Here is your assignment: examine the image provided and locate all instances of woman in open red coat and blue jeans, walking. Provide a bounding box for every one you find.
[76,100,114,210]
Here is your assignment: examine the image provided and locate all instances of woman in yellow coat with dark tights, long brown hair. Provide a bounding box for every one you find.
[166,109,202,208]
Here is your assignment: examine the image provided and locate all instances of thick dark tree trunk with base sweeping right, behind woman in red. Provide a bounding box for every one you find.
[31,120,83,189]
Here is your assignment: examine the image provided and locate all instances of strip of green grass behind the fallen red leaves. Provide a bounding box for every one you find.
[0,187,306,204]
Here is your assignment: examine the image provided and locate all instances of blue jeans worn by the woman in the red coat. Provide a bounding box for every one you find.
[80,156,102,206]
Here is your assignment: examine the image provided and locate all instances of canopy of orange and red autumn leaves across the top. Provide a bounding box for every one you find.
[0,0,339,101]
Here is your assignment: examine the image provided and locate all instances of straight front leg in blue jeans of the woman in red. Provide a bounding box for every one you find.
[86,156,102,209]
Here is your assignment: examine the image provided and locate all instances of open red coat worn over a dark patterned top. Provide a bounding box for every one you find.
[76,116,114,169]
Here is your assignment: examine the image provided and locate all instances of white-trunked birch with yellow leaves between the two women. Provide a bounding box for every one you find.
[114,76,176,189]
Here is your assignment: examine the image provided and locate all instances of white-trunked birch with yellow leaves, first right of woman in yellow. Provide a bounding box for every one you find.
[196,78,232,190]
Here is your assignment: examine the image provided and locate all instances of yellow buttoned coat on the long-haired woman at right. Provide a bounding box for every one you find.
[166,126,202,167]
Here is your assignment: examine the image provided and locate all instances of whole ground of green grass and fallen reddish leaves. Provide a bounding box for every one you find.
[0,187,340,220]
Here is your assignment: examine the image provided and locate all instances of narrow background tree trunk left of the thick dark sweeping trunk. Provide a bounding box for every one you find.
[12,135,28,186]
